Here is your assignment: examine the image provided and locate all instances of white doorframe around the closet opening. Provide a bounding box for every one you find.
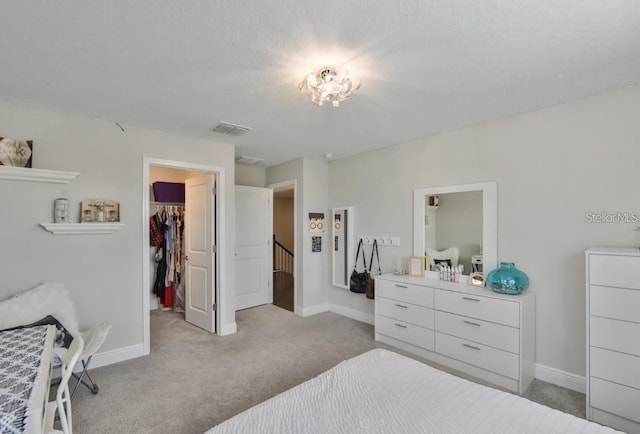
[141,157,227,355]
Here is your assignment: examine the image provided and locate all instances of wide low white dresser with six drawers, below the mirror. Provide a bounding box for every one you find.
[375,274,535,394]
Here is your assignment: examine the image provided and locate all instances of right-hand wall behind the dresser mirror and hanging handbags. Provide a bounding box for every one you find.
[329,86,640,375]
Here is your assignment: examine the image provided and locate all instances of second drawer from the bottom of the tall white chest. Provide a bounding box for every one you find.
[589,347,640,389]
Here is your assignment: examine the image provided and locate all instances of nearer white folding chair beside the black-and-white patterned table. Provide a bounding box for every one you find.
[44,336,84,434]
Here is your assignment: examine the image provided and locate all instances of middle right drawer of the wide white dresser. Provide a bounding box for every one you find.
[435,311,520,354]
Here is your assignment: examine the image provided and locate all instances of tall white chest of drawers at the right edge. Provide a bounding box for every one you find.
[586,248,640,433]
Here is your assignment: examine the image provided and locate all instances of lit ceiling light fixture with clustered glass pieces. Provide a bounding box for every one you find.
[298,67,361,107]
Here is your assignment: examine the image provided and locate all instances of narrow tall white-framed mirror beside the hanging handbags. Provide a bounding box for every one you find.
[331,206,355,288]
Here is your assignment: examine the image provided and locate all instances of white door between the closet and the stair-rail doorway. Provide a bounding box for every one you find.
[235,185,273,310]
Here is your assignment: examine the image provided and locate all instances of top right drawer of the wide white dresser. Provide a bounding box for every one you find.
[435,289,520,327]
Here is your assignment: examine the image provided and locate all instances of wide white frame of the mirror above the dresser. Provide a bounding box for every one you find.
[413,181,498,274]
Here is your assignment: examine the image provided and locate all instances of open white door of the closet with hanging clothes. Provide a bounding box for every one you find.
[184,175,216,333]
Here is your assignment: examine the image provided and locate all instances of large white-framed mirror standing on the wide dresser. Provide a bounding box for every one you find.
[413,182,498,275]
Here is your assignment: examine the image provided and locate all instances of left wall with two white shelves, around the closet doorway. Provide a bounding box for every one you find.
[0,103,235,360]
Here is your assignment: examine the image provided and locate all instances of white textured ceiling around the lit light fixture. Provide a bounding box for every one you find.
[0,0,640,166]
